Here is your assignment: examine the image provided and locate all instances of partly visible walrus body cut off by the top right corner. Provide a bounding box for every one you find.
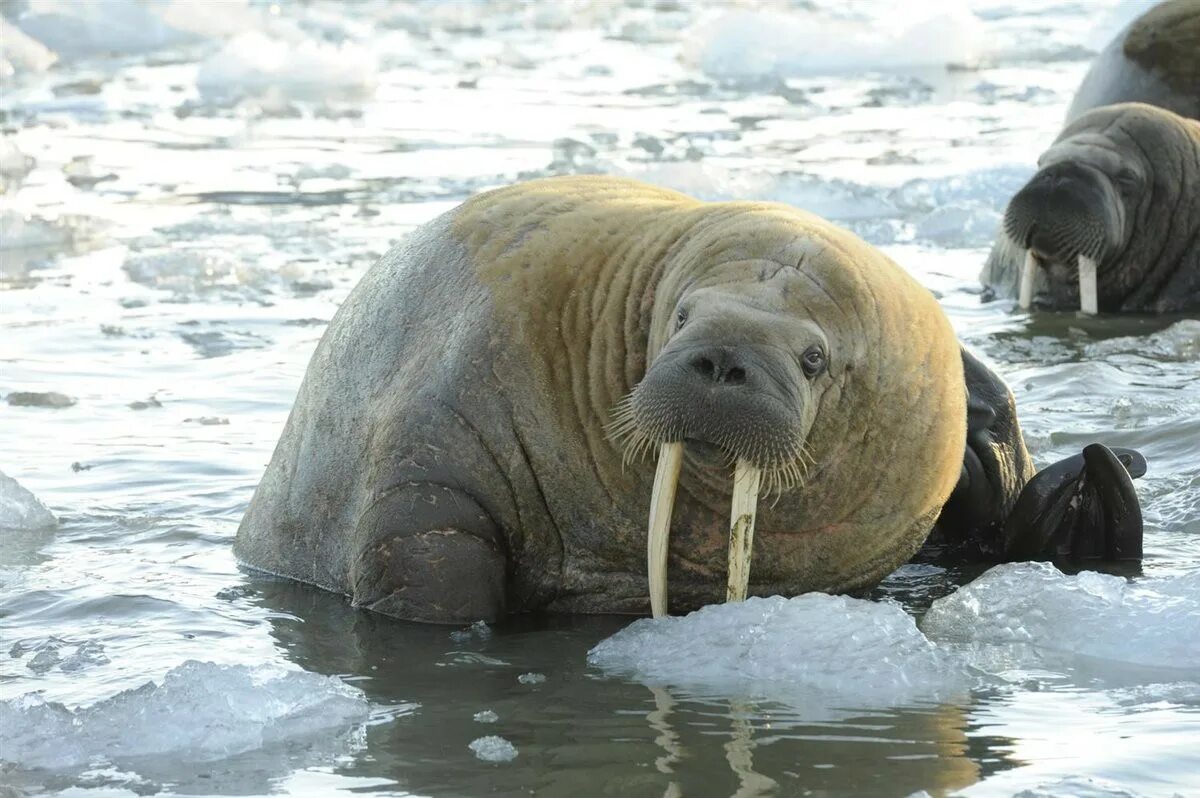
[1067,0,1200,122]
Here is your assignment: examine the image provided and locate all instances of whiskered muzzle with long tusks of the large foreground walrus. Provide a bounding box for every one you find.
[610,336,808,617]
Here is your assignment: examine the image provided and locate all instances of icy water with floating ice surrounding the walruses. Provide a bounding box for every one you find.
[0,0,1200,796]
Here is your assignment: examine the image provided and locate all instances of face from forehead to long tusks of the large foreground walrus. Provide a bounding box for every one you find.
[610,262,830,616]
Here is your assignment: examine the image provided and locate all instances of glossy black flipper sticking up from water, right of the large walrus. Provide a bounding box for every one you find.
[1004,443,1146,560]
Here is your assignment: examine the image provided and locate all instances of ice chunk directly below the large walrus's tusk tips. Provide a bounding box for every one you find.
[588,593,968,706]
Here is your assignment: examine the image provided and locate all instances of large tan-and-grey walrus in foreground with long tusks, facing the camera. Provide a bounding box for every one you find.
[235,176,1140,623]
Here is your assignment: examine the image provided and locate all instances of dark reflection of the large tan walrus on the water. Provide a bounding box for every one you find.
[251,578,1006,798]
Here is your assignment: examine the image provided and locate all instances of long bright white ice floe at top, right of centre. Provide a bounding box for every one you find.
[683,6,985,82]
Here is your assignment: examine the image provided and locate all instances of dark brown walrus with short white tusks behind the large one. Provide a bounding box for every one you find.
[980,103,1200,313]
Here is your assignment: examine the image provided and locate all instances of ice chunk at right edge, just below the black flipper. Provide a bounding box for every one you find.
[922,563,1200,672]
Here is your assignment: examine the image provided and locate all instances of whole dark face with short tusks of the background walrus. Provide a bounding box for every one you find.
[1004,130,1146,313]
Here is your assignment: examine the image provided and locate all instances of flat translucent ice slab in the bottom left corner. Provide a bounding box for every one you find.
[0,660,370,768]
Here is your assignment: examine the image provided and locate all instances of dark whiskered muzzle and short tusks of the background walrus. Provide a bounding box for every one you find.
[1004,161,1124,314]
